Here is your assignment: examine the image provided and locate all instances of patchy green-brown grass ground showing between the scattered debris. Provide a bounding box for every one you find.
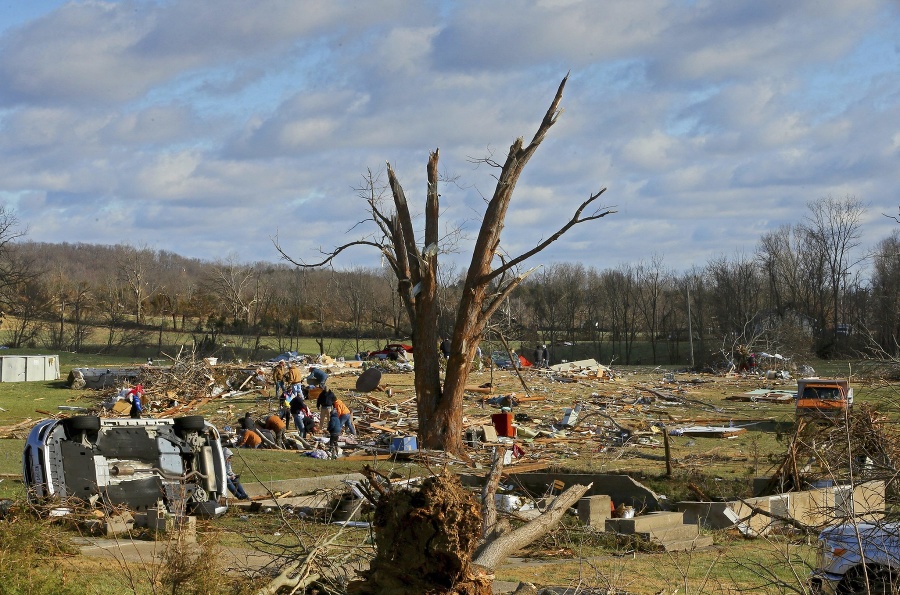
[0,354,898,594]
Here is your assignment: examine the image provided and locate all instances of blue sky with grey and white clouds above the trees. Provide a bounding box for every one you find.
[0,0,900,270]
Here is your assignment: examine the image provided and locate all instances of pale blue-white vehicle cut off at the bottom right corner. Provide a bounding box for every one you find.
[810,523,900,595]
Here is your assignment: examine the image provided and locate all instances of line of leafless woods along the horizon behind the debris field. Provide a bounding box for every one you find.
[0,197,900,365]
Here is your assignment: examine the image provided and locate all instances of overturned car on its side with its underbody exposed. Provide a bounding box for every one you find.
[22,415,227,516]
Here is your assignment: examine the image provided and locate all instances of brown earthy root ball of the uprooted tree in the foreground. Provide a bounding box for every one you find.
[350,470,493,595]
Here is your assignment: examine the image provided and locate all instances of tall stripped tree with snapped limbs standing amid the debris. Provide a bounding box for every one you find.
[275,76,613,453]
